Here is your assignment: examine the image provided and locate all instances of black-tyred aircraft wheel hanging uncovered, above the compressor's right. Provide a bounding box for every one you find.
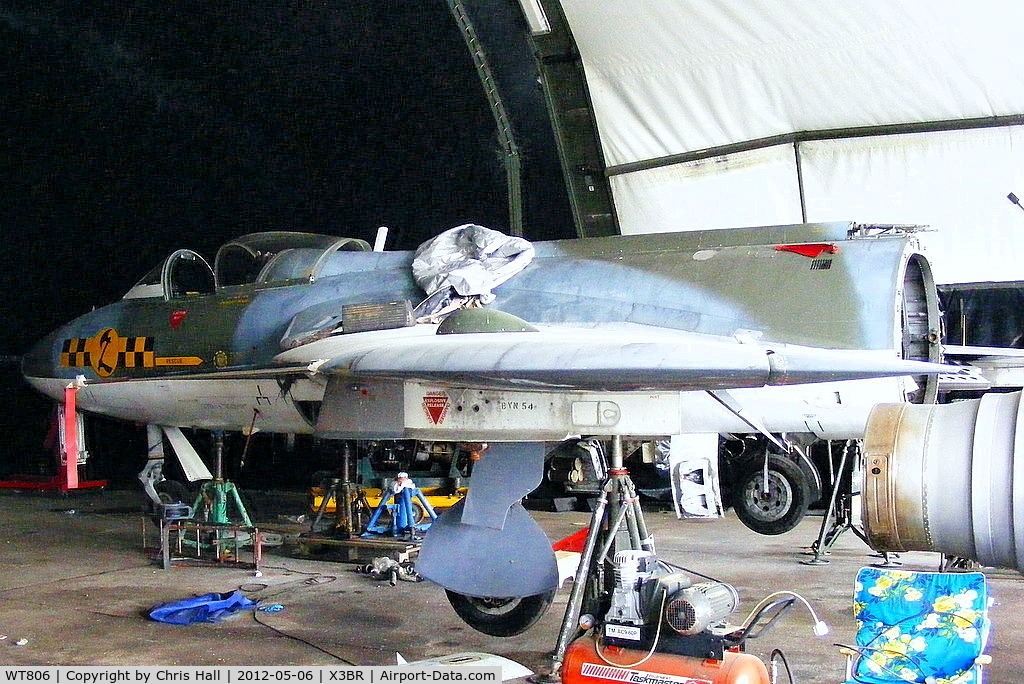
[733,454,811,535]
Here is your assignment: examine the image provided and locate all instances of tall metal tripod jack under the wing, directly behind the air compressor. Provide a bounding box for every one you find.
[537,436,654,682]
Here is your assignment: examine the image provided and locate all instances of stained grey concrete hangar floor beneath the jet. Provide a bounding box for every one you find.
[0,485,1024,684]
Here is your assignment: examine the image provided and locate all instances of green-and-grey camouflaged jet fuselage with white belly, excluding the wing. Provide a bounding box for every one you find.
[24,224,937,439]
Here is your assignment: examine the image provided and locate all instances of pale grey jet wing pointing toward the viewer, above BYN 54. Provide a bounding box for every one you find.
[275,324,950,391]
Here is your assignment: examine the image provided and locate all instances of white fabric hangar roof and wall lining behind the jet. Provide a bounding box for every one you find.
[560,0,1024,283]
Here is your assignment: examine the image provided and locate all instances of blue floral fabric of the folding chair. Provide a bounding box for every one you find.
[846,567,990,684]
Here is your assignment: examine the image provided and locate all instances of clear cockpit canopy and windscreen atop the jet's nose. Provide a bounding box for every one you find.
[124,230,370,300]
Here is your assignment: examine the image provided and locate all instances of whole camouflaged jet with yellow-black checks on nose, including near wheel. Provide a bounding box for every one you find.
[23,223,946,634]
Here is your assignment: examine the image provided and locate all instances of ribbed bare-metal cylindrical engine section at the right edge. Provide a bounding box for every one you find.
[862,392,1024,571]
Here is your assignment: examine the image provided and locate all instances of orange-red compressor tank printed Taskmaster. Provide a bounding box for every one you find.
[561,637,771,684]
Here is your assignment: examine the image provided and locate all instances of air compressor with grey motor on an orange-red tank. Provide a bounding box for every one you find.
[561,550,770,684]
